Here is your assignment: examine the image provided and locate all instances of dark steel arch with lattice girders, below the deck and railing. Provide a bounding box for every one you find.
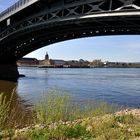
[0,0,140,61]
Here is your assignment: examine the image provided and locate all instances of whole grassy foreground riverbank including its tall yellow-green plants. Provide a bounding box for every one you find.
[0,94,140,140]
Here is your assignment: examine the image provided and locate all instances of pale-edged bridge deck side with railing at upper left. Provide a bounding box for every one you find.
[0,0,39,22]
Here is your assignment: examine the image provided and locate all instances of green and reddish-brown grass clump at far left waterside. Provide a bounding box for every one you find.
[0,91,33,130]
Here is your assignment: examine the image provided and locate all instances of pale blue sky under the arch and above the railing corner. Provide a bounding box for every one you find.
[0,0,140,62]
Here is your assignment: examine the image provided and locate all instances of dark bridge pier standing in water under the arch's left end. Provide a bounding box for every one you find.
[0,64,20,80]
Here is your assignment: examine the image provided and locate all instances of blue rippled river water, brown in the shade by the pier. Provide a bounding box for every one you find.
[0,67,140,107]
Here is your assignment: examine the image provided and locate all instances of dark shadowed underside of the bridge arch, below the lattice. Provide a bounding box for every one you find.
[0,12,140,64]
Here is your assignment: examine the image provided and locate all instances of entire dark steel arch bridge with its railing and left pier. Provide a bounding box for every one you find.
[0,0,140,78]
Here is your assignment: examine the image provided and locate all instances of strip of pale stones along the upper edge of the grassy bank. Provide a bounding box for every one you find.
[7,109,140,140]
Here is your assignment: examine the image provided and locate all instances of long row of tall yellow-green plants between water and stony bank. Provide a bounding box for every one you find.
[34,94,115,124]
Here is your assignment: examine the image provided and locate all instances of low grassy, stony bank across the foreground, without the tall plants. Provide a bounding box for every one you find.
[0,109,140,140]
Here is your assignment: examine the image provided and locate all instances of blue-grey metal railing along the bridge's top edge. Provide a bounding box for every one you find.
[0,0,37,21]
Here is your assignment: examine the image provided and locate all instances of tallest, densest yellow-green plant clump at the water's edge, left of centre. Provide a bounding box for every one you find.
[35,96,70,123]
